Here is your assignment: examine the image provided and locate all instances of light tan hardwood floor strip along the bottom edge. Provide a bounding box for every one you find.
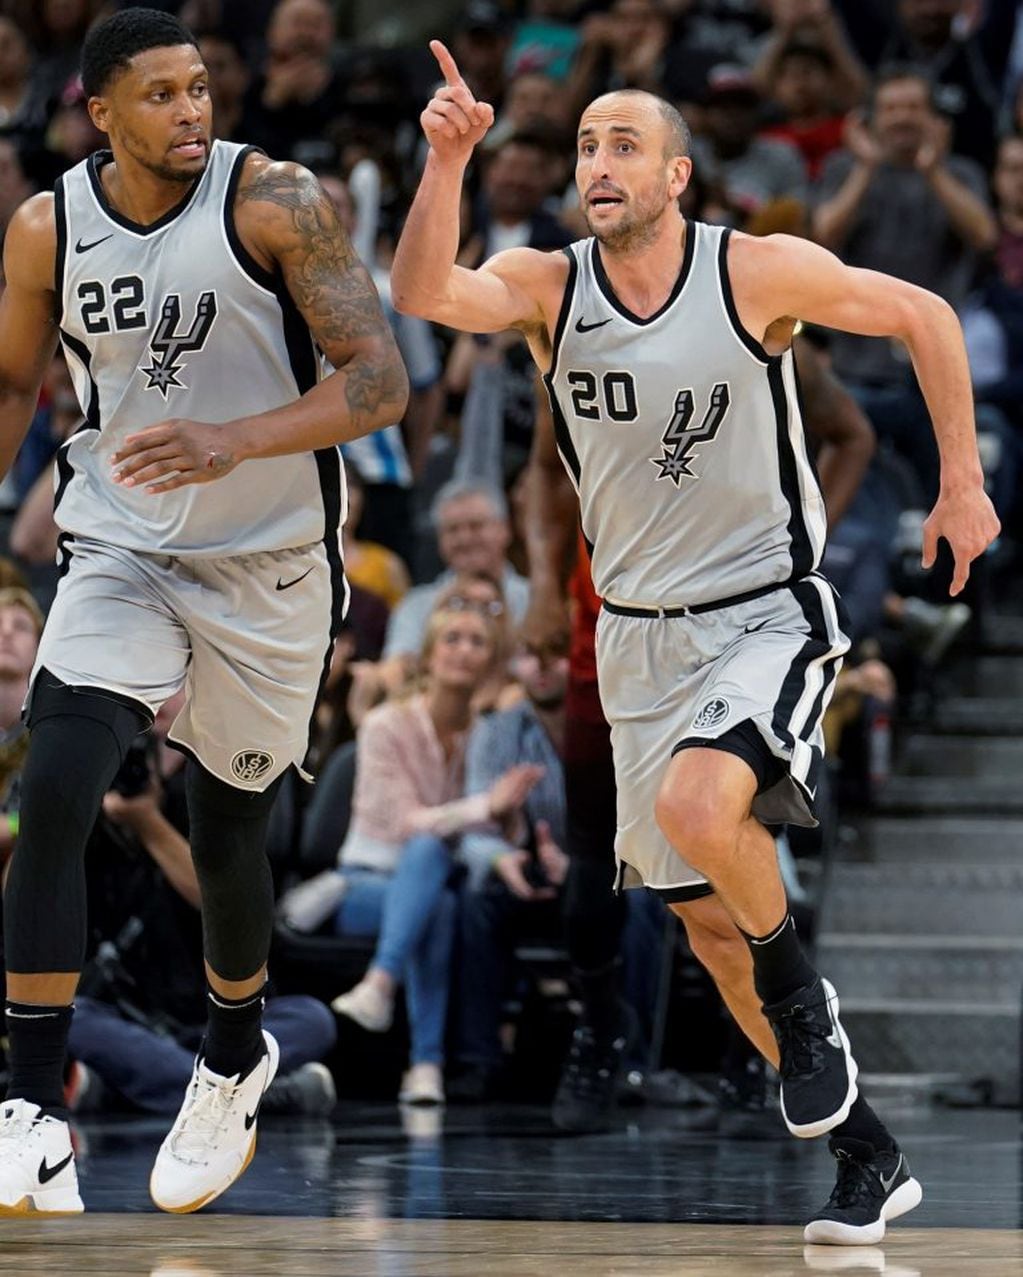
[0,1214,1023,1277]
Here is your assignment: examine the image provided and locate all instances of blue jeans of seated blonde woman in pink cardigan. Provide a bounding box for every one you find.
[335,834,456,1064]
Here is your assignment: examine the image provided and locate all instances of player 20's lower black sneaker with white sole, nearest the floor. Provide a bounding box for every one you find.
[803,1135,923,1246]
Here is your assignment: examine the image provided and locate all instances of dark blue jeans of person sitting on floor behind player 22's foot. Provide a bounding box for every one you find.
[68,996,337,1114]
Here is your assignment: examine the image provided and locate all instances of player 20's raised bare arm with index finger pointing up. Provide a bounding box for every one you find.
[391,40,559,338]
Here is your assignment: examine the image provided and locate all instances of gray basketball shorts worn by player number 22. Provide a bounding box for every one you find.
[29,538,344,792]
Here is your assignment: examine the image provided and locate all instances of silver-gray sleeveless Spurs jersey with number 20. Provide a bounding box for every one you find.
[545,222,825,607]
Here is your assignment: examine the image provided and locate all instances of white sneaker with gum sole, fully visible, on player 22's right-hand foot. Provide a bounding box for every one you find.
[149,1029,281,1214]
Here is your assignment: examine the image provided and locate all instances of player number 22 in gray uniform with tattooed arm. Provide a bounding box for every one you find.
[0,9,406,1214]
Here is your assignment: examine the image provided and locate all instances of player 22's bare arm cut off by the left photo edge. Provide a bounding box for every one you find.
[0,195,57,478]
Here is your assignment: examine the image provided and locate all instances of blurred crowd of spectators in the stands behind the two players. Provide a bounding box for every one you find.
[0,0,1023,1108]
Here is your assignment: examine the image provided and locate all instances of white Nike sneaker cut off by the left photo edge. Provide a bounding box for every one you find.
[0,1099,86,1216]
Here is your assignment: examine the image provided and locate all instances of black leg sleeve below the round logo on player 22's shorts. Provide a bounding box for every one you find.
[185,761,282,981]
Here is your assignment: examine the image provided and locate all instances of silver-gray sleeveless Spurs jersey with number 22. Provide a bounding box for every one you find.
[55,142,346,557]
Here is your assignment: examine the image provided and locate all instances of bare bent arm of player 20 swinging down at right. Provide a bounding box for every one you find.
[728,235,999,594]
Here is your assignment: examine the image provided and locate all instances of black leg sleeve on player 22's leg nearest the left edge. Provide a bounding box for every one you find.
[4,669,152,976]
